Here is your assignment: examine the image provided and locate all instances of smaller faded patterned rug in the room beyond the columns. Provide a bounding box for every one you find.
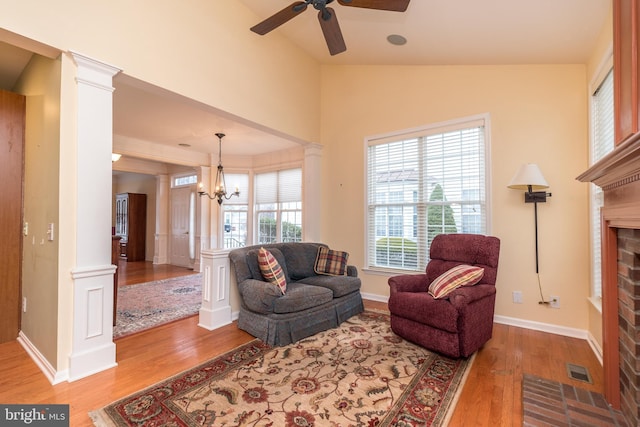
[113,274,202,338]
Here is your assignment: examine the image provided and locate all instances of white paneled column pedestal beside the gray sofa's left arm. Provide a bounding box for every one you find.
[198,249,231,331]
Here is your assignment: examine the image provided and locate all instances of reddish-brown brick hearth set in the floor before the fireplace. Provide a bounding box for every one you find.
[522,374,627,427]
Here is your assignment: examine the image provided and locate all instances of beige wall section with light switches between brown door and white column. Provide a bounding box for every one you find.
[14,55,60,362]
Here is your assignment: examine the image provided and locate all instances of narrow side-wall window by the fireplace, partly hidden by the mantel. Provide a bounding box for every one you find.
[589,71,614,298]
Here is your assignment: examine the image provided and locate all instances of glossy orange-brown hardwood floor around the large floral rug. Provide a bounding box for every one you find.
[0,263,603,427]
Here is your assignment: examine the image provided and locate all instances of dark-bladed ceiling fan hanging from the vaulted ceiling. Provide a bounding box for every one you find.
[251,0,410,55]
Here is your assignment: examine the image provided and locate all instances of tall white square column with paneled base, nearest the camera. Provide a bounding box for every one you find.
[67,52,121,381]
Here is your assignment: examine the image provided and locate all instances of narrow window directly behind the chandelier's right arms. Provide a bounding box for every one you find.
[222,173,249,249]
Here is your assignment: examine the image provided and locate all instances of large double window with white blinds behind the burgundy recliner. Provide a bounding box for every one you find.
[366,115,489,271]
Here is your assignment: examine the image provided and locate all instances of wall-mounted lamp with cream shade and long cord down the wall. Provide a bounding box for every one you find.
[508,163,551,304]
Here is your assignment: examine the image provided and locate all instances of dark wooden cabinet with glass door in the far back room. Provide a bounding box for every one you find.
[116,193,147,261]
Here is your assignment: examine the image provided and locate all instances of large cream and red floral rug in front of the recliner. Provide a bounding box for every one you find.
[90,311,473,427]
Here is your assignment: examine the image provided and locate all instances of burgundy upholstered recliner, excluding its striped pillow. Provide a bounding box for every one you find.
[389,234,500,358]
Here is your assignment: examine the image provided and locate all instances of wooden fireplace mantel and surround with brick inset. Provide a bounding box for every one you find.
[577,134,640,425]
